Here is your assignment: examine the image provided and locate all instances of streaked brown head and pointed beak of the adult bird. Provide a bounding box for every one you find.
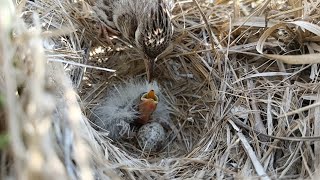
[135,0,173,82]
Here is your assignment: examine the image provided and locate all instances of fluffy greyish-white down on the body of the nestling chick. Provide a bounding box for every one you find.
[91,80,170,139]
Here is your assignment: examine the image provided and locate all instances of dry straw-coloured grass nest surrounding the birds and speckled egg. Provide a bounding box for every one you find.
[0,0,320,179]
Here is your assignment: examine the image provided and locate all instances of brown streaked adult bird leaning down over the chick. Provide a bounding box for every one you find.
[93,0,173,82]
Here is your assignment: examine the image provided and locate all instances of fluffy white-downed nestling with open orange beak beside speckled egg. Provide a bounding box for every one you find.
[91,81,170,139]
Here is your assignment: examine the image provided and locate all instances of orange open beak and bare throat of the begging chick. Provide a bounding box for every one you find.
[137,90,158,124]
